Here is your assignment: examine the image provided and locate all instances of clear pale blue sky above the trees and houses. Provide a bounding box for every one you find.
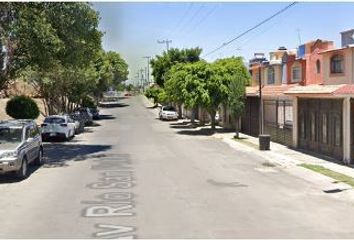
[93,2,354,85]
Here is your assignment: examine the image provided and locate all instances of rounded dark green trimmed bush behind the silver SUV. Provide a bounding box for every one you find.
[6,96,39,119]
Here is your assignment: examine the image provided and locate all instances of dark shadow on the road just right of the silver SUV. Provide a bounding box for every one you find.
[43,143,112,168]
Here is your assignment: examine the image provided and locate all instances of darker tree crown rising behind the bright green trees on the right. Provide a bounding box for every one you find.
[151,47,202,87]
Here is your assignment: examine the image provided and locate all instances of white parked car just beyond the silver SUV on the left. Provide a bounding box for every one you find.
[41,115,75,140]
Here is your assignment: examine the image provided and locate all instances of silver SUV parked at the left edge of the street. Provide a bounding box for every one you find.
[0,120,43,179]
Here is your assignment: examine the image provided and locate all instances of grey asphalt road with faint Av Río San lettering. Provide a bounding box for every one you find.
[0,96,354,238]
